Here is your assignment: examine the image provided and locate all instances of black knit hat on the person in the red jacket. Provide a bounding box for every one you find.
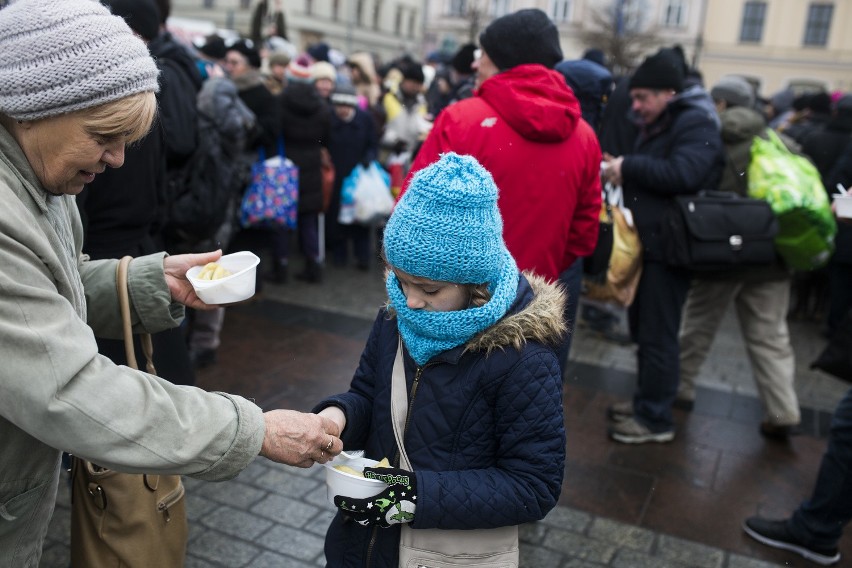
[479,8,562,71]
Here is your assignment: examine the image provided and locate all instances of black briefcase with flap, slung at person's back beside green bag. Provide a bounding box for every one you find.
[662,191,778,271]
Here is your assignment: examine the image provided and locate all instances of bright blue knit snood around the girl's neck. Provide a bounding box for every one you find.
[385,252,520,366]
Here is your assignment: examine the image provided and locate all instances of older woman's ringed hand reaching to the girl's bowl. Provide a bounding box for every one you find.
[260,410,343,467]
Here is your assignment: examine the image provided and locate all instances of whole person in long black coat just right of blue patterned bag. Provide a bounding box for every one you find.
[273,62,331,284]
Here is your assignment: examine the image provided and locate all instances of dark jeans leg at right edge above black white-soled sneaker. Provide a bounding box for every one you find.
[787,389,852,548]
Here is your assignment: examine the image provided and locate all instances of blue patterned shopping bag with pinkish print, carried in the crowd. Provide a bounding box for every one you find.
[240,138,299,229]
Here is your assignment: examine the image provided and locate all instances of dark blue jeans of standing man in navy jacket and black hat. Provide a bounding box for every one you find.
[627,262,690,432]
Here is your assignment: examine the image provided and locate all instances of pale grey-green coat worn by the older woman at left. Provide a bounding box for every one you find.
[0,127,264,568]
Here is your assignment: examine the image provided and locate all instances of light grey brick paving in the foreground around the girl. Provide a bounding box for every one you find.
[40,458,780,568]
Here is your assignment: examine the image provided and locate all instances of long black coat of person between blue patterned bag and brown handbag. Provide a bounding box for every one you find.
[280,81,331,213]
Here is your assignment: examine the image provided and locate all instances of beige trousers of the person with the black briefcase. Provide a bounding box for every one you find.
[678,278,800,426]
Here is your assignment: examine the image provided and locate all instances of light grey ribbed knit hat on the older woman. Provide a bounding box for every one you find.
[0,0,158,120]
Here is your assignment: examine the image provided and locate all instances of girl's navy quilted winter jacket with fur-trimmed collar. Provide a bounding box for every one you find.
[314,275,565,568]
